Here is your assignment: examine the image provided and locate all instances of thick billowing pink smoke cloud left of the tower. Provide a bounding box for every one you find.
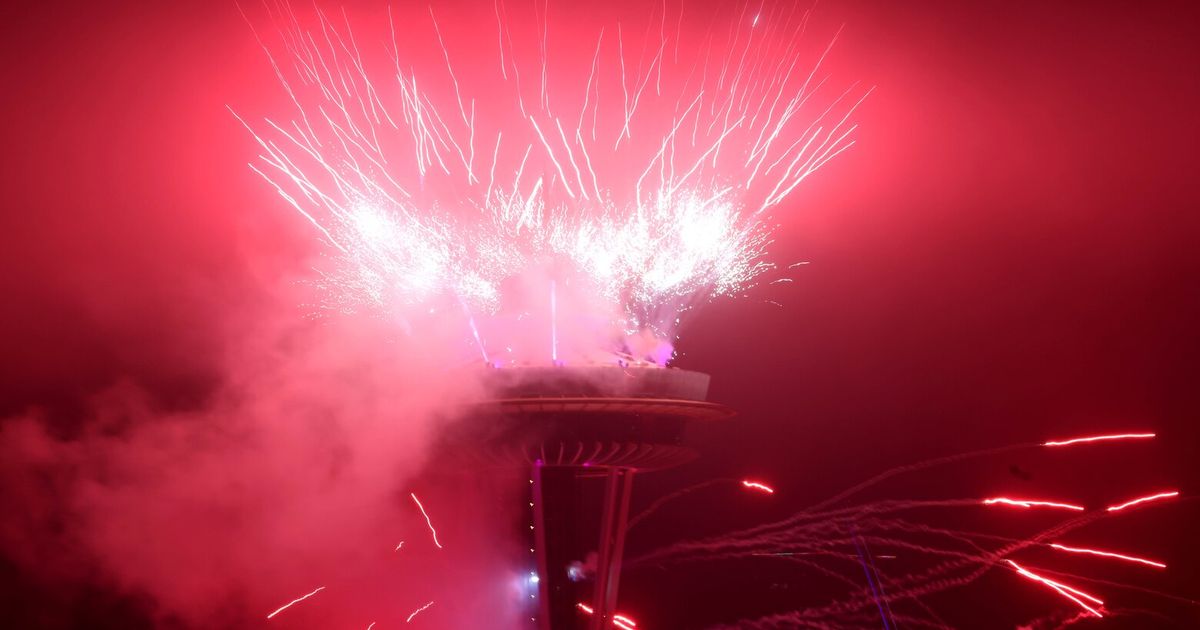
[0,283,517,628]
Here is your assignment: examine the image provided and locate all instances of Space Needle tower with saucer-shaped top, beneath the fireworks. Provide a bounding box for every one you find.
[472,365,733,630]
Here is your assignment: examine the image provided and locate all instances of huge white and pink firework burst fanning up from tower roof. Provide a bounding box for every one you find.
[235,4,871,365]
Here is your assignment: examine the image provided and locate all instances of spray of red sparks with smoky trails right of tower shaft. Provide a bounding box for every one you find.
[625,427,1194,628]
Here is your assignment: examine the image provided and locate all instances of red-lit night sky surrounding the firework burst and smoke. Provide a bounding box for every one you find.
[0,0,1200,629]
